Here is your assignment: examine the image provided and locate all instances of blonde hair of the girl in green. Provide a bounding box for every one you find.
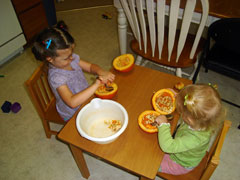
[176,84,223,131]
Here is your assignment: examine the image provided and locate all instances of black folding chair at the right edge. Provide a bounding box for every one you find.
[193,18,240,108]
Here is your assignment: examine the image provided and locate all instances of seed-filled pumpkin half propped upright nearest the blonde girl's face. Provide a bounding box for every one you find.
[152,89,175,115]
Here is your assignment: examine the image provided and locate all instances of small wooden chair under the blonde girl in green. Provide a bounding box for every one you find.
[157,120,232,180]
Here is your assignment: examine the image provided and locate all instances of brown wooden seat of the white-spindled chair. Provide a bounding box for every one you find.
[131,30,205,68]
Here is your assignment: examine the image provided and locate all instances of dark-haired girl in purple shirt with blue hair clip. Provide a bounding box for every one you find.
[32,21,115,121]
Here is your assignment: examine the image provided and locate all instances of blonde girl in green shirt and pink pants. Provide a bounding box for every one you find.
[156,84,223,175]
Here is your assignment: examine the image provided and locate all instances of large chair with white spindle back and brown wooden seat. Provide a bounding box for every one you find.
[120,0,209,79]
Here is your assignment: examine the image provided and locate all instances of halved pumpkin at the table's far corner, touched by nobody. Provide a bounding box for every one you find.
[113,54,134,72]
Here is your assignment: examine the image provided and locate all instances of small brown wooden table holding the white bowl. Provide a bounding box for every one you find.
[58,65,192,179]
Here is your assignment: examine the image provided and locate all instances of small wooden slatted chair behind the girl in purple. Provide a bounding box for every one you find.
[25,63,65,138]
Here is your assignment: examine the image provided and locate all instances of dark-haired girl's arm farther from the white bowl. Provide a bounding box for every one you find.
[79,60,115,84]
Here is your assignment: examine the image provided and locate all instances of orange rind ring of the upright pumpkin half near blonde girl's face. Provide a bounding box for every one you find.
[152,89,176,115]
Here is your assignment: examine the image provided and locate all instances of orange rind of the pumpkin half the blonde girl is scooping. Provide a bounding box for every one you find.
[138,110,160,133]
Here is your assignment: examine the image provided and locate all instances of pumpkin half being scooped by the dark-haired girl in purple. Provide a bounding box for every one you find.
[95,83,118,99]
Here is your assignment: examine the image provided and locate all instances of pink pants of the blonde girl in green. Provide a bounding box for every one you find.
[159,154,192,175]
